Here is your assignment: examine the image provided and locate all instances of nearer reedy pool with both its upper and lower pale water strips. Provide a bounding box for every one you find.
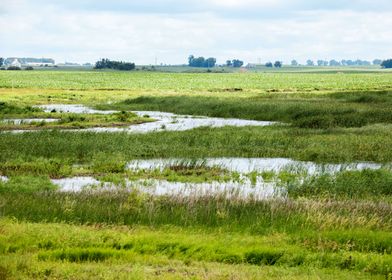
[0,158,386,200]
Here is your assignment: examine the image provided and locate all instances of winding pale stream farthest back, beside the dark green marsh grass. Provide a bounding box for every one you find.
[34,104,275,133]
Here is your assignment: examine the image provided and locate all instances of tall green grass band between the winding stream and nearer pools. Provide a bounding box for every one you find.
[0,126,392,163]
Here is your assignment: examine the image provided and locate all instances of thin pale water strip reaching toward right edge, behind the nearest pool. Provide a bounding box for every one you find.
[127,158,383,174]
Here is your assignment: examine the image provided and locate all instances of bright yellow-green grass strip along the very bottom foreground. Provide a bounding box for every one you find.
[0,219,392,279]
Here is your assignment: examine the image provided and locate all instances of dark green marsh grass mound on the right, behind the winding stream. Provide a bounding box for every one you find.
[98,92,392,129]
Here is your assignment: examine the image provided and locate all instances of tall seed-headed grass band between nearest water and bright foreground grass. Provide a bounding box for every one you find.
[1,191,392,233]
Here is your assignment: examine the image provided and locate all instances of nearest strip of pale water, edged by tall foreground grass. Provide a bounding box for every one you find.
[52,177,284,200]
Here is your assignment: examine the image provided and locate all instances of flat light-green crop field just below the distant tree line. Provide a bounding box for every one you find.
[0,71,392,92]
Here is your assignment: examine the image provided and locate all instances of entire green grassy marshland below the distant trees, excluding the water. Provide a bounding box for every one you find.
[0,68,392,279]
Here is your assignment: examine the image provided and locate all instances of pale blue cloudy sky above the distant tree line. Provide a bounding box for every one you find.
[0,0,392,64]
